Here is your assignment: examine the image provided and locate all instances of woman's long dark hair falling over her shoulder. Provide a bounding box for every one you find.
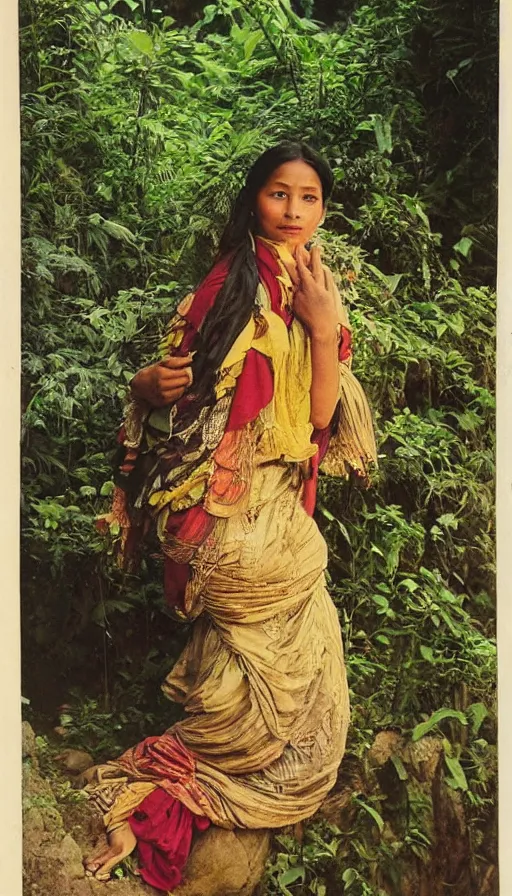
[192,140,334,398]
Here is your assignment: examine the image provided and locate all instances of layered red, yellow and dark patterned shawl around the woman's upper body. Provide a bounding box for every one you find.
[100,237,376,606]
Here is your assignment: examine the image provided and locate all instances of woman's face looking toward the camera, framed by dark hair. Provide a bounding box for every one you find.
[255,159,324,252]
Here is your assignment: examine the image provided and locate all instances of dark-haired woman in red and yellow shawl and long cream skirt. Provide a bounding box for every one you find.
[86,142,375,890]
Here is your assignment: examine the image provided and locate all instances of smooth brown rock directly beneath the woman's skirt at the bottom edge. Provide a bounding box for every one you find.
[173,827,270,896]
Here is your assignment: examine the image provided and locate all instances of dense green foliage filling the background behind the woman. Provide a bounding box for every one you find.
[21,0,497,896]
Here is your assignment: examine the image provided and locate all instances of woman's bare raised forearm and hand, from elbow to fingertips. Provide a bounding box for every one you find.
[293,247,339,429]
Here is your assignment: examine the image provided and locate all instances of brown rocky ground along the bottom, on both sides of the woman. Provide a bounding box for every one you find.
[23,722,498,896]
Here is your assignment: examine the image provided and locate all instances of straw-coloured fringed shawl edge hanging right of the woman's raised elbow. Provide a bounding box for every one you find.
[320,363,377,486]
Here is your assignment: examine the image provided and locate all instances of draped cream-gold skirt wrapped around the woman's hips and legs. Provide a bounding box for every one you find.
[88,463,349,829]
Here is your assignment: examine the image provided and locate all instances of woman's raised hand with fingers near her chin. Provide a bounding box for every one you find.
[290,246,339,339]
